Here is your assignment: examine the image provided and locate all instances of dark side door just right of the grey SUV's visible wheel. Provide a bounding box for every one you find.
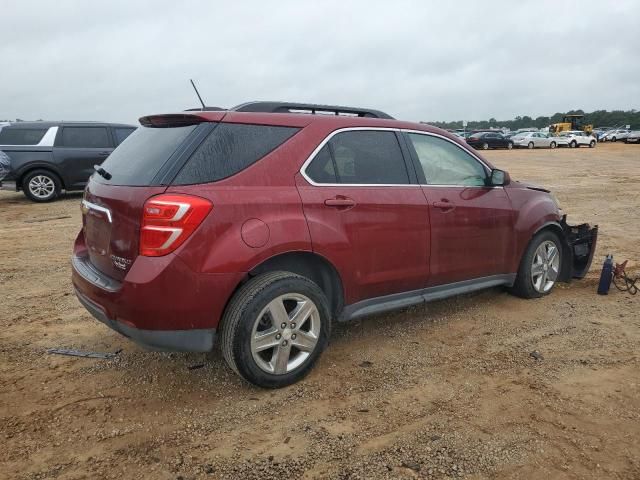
[53,125,114,189]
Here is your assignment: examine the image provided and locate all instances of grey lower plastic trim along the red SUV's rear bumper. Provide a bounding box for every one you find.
[76,289,216,352]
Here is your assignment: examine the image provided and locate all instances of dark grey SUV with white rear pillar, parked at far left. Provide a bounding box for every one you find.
[0,122,136,202]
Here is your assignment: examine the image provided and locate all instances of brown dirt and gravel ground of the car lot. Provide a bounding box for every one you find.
[0,144,640,480]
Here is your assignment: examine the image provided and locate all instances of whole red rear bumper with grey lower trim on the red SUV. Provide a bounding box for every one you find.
[72,232,245,352]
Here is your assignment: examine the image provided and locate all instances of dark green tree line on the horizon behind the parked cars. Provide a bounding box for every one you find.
[424,109,640,130]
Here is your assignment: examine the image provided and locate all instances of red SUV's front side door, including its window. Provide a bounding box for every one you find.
[406,132,514,285]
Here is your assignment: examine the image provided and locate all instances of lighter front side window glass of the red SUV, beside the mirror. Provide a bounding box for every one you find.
[408,133,487,186]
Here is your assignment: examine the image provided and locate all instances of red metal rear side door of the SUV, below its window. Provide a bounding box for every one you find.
[297,176,429,304]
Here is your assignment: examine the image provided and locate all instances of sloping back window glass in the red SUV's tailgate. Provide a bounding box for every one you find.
[94,125,196,186]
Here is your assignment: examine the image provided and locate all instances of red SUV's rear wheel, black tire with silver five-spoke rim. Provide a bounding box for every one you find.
[221,272,331,388]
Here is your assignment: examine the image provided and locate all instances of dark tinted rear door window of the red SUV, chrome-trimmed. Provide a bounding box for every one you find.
[314,130,410,185]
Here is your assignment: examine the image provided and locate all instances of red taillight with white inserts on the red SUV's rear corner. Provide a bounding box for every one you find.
[140,194,213,257]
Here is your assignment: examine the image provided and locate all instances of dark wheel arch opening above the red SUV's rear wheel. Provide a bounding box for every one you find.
[241,251,344,316]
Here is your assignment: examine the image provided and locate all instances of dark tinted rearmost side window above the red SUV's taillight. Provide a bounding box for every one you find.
[173,123,299,185]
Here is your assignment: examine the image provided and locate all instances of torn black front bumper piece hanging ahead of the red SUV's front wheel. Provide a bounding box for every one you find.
[559,215,598,282]
